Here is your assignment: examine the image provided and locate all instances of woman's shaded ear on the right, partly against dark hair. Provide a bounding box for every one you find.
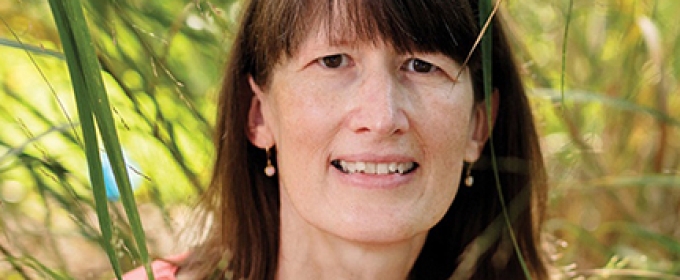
[465,89,500,162]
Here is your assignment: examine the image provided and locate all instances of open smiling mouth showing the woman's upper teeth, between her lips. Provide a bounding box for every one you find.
[331,159,419,175]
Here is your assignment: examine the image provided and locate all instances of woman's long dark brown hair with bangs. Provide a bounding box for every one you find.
[181,0,547,279]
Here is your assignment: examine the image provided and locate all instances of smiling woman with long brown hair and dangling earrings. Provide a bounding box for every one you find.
[122,0,547,279]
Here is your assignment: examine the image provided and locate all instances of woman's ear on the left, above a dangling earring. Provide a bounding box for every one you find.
[247,76,275,149]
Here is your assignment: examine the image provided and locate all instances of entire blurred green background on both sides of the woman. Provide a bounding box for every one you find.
[0,0,680,279]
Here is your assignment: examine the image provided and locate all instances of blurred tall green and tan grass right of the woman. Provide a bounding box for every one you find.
[508,1,680,279]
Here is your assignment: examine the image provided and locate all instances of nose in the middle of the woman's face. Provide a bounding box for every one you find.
[349,69,409,136]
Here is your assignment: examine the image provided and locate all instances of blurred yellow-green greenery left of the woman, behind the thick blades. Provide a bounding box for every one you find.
[0,1,237,279]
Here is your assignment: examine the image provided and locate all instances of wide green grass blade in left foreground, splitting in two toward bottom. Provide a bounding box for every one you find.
[49,0,154,280]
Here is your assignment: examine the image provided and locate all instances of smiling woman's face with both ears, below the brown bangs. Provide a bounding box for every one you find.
[249,29,487,243]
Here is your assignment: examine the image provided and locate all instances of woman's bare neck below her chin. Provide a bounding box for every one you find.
[277,201,427,280]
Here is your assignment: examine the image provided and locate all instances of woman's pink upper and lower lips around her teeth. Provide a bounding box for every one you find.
[328,155,420,190]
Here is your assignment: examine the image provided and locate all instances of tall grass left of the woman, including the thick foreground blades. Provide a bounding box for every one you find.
[0,1,236,279]
